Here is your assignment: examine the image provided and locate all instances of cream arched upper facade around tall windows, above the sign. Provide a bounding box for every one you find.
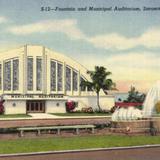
[0,45,90,95]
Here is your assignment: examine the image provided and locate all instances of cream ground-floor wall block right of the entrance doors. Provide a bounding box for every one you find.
[45,100,66,113]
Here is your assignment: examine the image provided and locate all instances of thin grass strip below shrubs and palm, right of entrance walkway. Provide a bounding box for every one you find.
[50,112,111,116]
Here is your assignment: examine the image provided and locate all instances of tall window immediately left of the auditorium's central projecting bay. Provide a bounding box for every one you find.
[13,59,19,91]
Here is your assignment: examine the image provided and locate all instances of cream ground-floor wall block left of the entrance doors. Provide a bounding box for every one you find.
[4,100,26,114]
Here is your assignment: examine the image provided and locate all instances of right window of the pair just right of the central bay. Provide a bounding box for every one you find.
[57,63,63,91]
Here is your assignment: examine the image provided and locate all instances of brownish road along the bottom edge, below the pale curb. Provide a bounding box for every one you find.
[0,147,160,160]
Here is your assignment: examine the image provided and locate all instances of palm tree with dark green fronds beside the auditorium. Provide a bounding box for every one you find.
[81,66,116,111]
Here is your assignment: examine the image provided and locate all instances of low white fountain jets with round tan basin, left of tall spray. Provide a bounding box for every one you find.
[111,106,150,133]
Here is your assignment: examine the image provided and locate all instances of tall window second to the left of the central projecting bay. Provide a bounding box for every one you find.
[4,61,11,91]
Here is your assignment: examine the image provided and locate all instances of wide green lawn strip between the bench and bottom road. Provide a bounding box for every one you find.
[0,135,160,154]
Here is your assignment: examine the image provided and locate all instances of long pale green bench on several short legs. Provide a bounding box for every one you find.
[17,125,95,137]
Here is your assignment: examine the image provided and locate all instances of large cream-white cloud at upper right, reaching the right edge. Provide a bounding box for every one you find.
[88,27,160,50]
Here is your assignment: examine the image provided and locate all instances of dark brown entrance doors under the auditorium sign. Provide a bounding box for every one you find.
[26,100,45,113]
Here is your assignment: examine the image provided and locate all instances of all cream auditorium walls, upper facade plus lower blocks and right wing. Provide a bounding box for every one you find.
[0,45,114,114]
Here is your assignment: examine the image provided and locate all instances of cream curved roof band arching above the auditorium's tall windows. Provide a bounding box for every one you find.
[0,45,90,80]
